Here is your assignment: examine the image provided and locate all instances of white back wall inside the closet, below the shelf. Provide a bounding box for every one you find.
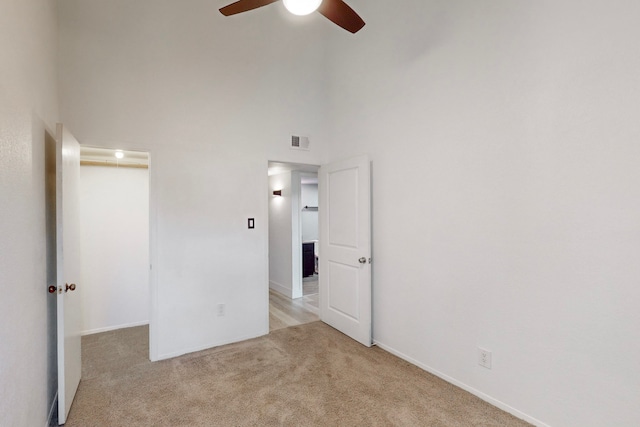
[80,166,150,334]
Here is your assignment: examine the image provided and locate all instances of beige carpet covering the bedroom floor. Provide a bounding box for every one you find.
[66,322,529,427]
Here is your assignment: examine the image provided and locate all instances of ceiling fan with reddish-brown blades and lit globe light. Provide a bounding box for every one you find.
[220,0,364,34]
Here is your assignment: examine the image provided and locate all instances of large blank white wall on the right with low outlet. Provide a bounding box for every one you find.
[327,0,640,427]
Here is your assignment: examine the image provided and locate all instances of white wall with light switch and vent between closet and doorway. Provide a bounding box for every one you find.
[59,0,330,358]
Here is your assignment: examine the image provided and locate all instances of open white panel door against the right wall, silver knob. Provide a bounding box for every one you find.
[318,156,372,347]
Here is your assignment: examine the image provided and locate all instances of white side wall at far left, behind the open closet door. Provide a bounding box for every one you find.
[0,0,58,426]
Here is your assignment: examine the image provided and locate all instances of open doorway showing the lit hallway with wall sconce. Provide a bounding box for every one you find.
[268,162,321,331]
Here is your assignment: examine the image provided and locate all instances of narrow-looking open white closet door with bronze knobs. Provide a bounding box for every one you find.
[56,124,82,424]
